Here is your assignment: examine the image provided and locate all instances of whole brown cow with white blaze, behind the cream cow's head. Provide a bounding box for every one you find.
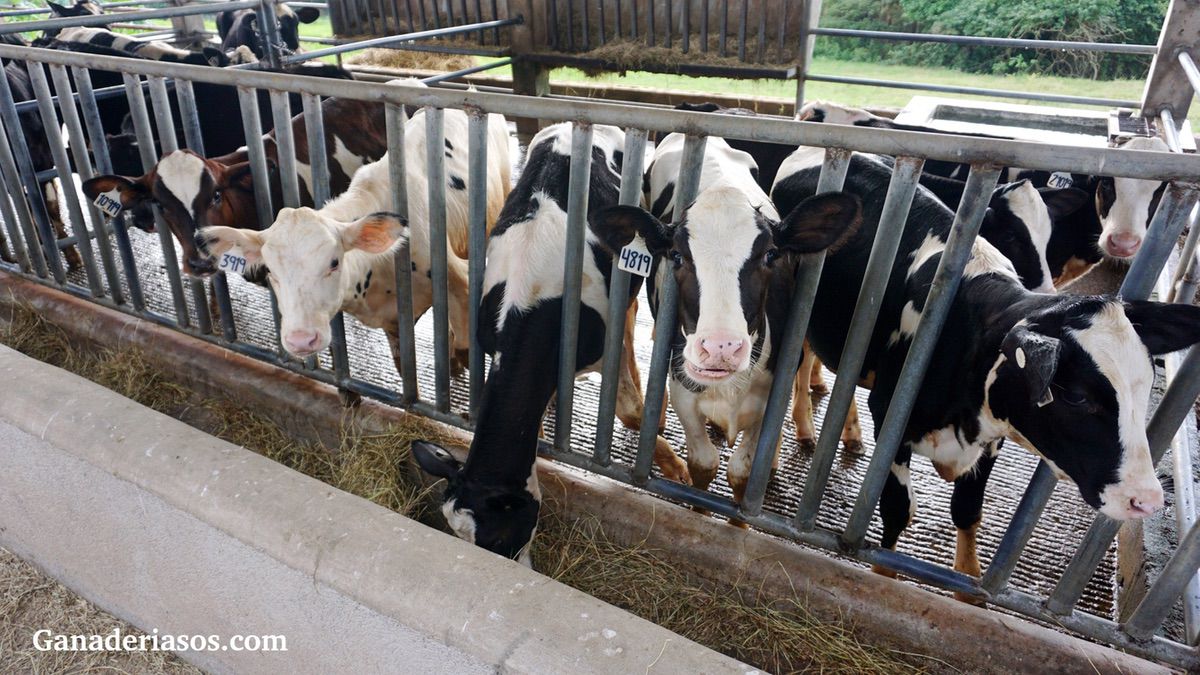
[83,98,388,275]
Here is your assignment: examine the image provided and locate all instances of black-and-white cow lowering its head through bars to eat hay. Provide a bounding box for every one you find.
[413,124,688,565]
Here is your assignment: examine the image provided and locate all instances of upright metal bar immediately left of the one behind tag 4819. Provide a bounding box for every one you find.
[554,123,593,450]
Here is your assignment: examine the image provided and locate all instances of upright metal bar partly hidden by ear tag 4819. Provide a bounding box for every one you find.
[592,129,647,466]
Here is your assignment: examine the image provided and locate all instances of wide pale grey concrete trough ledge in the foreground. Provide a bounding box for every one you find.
[0,347,752,673]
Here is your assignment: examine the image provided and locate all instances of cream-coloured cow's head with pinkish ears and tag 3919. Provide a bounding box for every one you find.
[196,207,408,358]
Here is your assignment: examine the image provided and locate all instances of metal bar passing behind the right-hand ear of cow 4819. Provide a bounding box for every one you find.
[740,148,854,515]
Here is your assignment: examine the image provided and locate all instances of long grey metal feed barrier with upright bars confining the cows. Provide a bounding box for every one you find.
[0,2,1200,668]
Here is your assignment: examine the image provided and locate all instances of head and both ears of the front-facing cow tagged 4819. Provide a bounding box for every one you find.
[592,187,860,386]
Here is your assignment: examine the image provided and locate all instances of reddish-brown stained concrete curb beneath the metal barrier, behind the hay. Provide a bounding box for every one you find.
[0,273,1169,674]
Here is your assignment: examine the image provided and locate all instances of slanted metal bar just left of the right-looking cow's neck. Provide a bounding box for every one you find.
[842,165,1000,548]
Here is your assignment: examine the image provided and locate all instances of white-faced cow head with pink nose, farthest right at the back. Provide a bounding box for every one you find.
[1096,137,1168,262]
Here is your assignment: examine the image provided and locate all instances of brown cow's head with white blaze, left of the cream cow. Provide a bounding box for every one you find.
[83,150,268,275]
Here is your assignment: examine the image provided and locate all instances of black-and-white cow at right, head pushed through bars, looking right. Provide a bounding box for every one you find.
[772,147,1200,593]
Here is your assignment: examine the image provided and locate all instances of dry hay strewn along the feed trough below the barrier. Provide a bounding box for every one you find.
[0,305,944,674]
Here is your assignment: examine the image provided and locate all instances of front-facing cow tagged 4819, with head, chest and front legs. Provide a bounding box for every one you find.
[633,133,858,509]
